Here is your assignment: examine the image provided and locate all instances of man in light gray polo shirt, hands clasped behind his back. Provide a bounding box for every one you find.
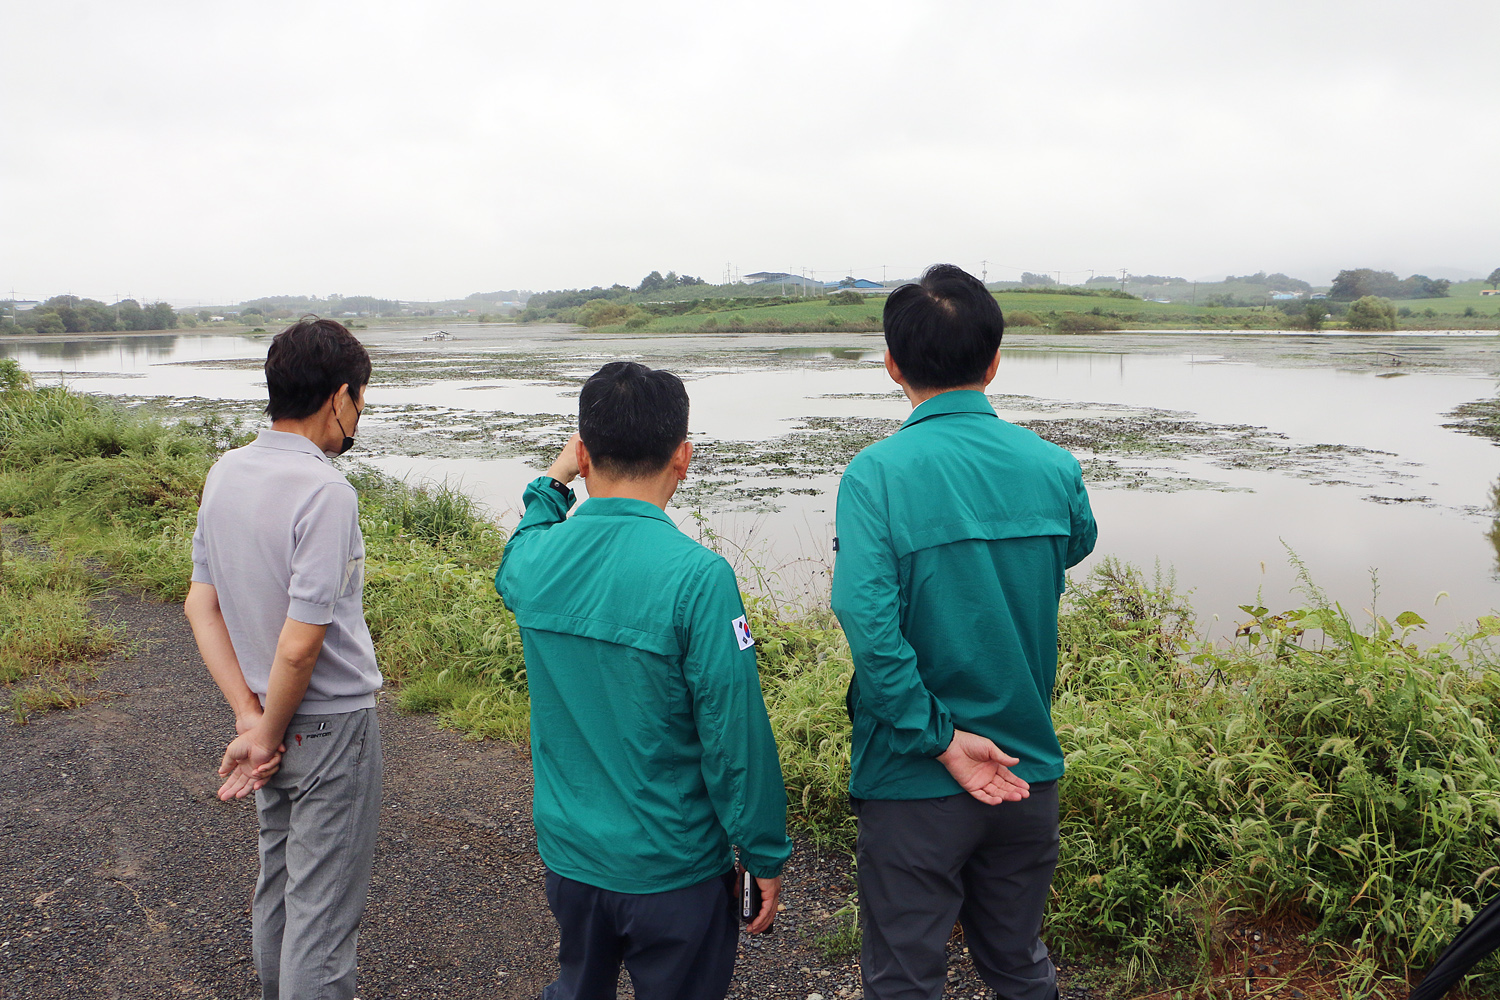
[185,319,381,1000]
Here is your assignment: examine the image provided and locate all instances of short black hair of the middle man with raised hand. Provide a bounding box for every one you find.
[578,361,687,478]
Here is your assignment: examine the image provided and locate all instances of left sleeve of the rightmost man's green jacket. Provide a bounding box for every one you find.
[833,472,953,757]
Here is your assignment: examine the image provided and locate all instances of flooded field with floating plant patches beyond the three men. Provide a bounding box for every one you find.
[0,325,1500,634]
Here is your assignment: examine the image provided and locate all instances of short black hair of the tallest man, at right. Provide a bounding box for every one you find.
[881,264,1005,390]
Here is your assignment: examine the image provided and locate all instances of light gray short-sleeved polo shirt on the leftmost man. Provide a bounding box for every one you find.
[192,430,383,715]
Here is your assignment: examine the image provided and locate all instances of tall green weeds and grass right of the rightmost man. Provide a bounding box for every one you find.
[1050,562,1500,975]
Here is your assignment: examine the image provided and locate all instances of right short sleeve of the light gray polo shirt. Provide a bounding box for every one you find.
[287,483,363,625]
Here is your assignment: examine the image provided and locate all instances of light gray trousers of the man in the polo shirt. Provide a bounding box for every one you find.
[252,708,383,1000]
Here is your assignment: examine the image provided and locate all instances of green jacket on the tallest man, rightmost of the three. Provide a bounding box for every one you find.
[833,390,1097,799]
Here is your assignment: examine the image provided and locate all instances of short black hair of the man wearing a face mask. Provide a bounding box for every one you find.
[266,316,371,420]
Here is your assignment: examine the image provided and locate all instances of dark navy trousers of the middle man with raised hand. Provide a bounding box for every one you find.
[542,871,740,1000]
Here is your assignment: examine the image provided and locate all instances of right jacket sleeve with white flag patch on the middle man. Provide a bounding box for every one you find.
[681,559,792,879]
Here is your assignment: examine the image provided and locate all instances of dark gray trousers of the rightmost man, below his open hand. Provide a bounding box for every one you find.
[854,781,1058,1000]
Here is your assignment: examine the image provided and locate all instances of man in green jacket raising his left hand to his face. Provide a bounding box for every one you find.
[495,361,792,1000]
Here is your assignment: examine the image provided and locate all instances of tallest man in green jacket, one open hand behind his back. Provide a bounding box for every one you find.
[833,265,1097,1000]
